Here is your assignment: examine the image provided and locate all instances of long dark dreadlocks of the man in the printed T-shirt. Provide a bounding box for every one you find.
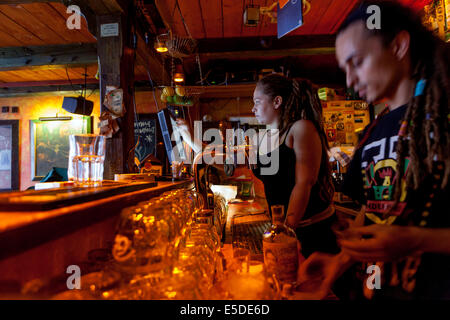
[338,1,450,203]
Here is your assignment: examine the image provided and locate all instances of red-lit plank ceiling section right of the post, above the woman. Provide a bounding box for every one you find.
[156,0,357,84]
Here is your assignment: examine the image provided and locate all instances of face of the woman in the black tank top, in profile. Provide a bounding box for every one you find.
[252,85,281,124]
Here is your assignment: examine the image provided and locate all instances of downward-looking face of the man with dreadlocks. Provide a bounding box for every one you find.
[336,21,400,103]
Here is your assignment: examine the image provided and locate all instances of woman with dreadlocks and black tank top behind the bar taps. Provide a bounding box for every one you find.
[252,74,337,257]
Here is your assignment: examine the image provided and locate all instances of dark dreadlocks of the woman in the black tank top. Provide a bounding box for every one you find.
[257,74,334,201]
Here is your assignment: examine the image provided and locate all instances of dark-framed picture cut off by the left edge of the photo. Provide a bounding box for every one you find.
[0,120,20,192]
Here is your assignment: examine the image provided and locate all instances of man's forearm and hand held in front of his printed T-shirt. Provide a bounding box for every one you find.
[338,224,422,262]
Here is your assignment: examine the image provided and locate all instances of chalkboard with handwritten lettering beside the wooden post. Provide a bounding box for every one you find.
[134,115,157,162]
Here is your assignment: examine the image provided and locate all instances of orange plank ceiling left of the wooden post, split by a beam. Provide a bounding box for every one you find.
[0,2,97,83]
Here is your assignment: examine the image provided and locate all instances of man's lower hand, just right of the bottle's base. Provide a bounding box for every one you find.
[297,252,354,300]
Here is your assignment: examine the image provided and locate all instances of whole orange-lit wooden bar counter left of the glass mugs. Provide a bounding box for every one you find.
[0,180,194,293]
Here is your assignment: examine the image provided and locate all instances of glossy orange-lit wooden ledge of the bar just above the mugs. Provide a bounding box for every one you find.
[0,180,193,259]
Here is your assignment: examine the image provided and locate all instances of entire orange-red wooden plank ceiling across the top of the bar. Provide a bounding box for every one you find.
[0,0,429,86]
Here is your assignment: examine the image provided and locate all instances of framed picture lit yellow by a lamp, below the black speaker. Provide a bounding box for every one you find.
[30,117,92,181]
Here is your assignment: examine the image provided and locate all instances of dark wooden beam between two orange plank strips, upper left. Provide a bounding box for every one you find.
[0,44,97,71]
